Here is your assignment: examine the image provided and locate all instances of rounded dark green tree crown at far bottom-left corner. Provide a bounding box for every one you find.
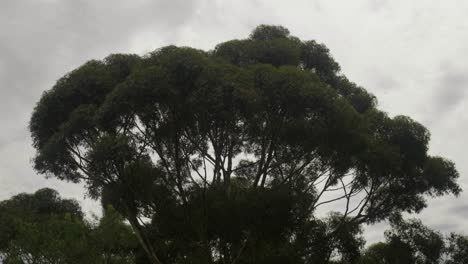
[0,189,96,263]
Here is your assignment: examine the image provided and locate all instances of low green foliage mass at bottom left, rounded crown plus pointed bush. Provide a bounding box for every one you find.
[0,189,137,264]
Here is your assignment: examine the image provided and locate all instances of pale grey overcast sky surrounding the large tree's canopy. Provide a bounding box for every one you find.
[0,0,468,243]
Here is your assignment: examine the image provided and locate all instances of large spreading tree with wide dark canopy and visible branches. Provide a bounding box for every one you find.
[30,25,460,263]
